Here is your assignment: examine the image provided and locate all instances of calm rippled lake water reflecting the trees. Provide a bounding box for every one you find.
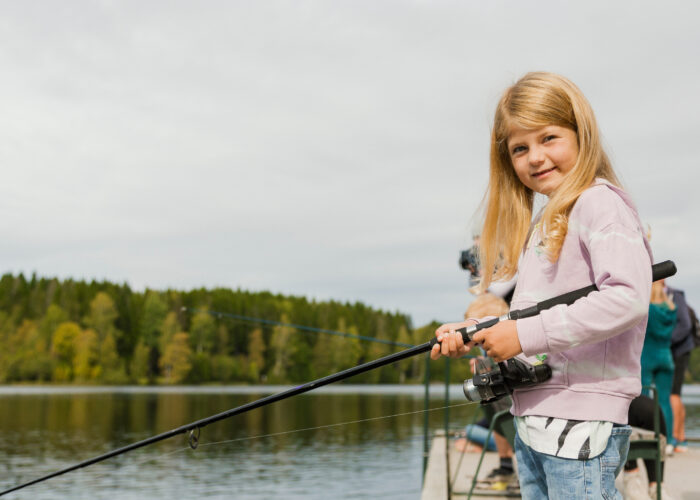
[0,386,700,500]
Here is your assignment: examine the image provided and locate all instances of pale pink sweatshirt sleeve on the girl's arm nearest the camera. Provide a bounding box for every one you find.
[517,189,652,356]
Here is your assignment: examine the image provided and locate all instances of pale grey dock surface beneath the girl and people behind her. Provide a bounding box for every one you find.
[421,431,700,500]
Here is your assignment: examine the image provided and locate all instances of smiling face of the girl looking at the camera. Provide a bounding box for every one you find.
[507,125,578,196]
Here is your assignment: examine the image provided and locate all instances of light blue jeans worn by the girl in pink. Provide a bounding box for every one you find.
[515,425,632,500]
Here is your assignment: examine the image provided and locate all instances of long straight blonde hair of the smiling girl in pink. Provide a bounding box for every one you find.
[480,72,620,290]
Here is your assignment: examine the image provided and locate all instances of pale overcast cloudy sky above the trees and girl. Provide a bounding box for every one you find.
[0,0,700,326]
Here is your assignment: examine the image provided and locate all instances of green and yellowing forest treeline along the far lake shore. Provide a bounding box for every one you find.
[0,274,454,384]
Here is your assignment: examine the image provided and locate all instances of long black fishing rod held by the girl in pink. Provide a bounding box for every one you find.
[0,260,676,496]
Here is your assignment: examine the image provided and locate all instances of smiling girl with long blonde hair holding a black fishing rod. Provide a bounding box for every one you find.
[431,73,652,499]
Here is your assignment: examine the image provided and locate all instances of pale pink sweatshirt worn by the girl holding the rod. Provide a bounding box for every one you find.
[511,179,652,424]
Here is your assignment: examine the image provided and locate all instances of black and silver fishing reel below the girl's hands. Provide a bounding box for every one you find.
[464,358,552,403]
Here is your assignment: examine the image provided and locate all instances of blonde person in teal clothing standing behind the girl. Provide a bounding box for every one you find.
[642,280,676,442]
